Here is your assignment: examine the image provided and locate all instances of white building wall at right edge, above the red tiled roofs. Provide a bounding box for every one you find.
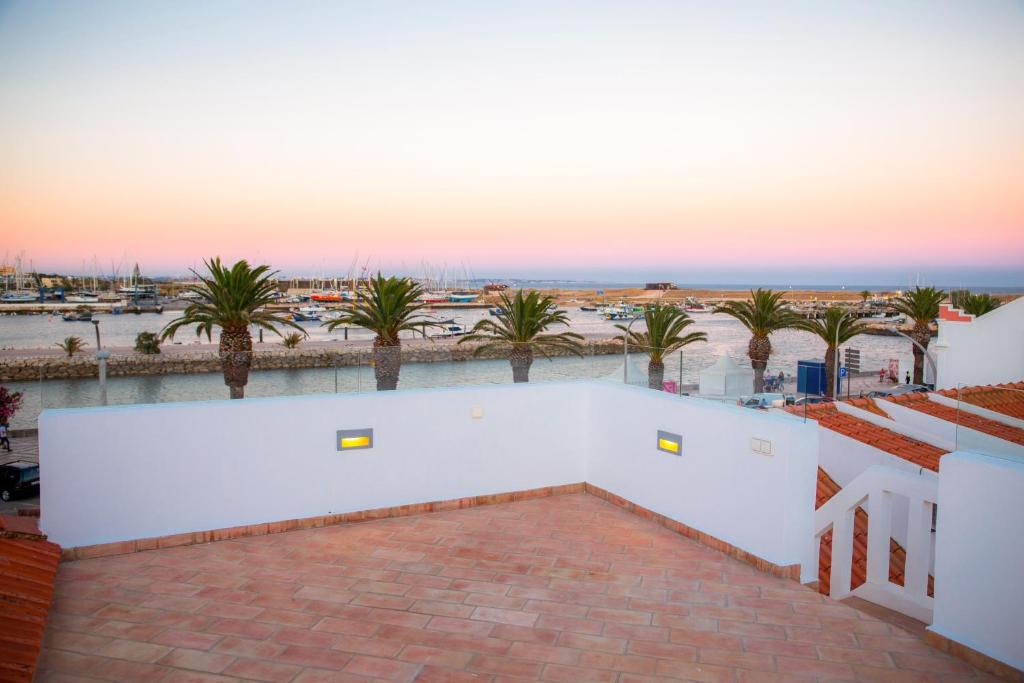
[929,297,1024,389]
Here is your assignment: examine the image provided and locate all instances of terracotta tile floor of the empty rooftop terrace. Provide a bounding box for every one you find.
[39,495,980,683]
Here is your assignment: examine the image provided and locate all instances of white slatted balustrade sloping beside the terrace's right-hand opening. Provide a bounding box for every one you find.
[812,465,938,624]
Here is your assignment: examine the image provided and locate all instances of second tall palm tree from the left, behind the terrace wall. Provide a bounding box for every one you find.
[327,272,436,391]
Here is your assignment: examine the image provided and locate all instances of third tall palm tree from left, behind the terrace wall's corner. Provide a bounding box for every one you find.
[459,290,583,382]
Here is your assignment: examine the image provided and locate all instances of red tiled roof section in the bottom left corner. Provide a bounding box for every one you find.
[0,515,60,681]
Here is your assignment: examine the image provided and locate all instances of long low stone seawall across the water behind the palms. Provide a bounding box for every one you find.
[0,339,623,382]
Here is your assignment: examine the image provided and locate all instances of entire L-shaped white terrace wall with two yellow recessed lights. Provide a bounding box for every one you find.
[39,382,818,578]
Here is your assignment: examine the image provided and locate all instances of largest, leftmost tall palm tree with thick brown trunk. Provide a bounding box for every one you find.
[160,257,306,398]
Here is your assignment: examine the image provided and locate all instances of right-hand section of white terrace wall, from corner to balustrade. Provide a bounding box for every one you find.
[587,387,818,581]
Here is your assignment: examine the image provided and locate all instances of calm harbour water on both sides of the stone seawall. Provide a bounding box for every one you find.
[0,309,912,428]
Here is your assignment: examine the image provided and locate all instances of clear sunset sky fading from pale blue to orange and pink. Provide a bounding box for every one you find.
[0,0,1024,286]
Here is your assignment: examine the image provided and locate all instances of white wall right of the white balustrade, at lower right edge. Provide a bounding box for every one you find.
[929,452,1024,669]
